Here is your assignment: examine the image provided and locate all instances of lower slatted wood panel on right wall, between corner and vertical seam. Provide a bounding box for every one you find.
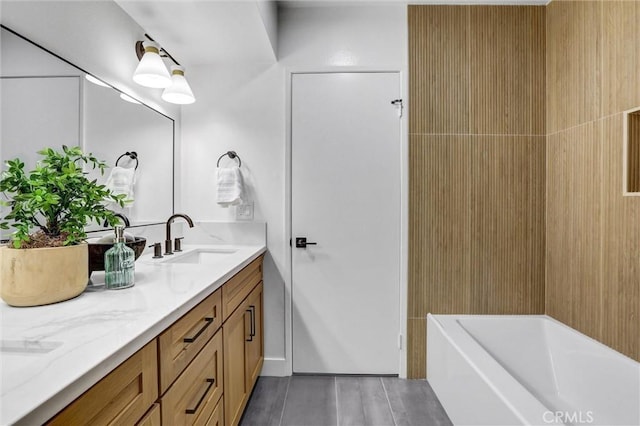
[545,122,603,335]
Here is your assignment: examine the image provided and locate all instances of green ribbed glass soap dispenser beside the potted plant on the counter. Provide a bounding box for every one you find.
[104,225,135,290]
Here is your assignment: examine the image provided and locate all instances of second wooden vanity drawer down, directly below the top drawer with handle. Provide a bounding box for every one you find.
[160,332,223,425]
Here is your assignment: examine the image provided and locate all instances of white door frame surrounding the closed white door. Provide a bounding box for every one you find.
[282,67,409,378]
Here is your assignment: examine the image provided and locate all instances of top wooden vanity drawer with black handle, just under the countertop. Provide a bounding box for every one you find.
[158,289,222,394]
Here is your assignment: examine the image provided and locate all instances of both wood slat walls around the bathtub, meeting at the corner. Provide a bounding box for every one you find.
[408,0,640,377]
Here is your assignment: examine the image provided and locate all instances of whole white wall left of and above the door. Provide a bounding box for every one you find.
[181,5,407,375]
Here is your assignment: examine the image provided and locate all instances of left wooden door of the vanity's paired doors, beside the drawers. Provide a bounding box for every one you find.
[222,300,251,426]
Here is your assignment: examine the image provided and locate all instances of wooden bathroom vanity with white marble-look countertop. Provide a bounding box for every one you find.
[0,245,265,426]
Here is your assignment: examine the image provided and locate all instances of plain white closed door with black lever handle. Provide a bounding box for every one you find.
[291,73,400,374]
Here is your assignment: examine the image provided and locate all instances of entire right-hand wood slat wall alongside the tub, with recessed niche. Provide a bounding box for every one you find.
[545,1,640,360]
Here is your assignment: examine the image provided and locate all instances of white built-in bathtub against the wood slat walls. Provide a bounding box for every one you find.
[427,314,640,426]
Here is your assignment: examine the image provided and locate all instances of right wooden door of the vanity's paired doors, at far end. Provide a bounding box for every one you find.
[245,282,264,393]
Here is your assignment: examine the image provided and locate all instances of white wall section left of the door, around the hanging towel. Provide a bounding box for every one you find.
[180,61,288,372]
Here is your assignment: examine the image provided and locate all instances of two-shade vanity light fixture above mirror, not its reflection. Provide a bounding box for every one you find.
[133,34,196,105]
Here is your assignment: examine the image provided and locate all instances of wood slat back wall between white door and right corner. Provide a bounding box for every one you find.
[407,6,546,378]
